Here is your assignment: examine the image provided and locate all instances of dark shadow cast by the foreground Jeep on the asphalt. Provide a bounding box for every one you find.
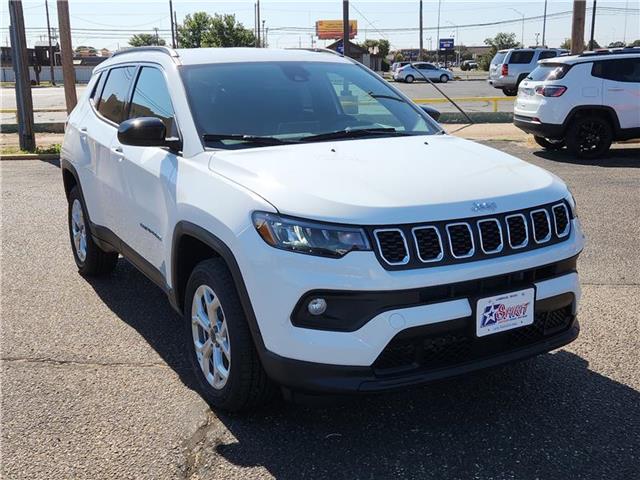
[90,260,640,479]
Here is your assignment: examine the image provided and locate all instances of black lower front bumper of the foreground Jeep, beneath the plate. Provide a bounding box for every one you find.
[263,294,580,394]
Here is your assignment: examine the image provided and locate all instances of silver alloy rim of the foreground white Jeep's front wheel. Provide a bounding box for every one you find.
[191,285,231,390]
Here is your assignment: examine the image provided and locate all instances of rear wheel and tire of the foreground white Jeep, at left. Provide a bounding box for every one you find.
[67,187,118,276]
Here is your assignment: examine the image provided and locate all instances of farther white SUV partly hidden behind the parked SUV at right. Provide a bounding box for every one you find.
[487,48,567,97]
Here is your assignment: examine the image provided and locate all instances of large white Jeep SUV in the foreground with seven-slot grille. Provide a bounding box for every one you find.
[61,47,584,410]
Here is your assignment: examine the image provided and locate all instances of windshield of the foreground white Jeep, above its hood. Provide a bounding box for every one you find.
[181,62,440,148]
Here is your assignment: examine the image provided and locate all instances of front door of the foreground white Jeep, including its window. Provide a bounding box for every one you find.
[115,65,179,272]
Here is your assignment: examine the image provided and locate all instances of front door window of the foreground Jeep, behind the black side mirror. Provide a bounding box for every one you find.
[129,67,175,136]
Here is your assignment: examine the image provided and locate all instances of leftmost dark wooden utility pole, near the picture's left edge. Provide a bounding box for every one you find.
[9,0,36,152]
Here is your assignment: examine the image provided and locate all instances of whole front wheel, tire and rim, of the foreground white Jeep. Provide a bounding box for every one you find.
[184,258,274,411]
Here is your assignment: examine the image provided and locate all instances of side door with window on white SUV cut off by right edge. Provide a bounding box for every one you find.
[592,58,640,129]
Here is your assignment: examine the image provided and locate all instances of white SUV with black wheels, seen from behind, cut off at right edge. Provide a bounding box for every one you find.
[514,47,640,158]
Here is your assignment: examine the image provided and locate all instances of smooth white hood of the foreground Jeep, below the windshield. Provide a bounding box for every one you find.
[209,135,567,225]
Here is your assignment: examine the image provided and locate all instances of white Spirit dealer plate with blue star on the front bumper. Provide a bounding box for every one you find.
[476,288,535,337]
